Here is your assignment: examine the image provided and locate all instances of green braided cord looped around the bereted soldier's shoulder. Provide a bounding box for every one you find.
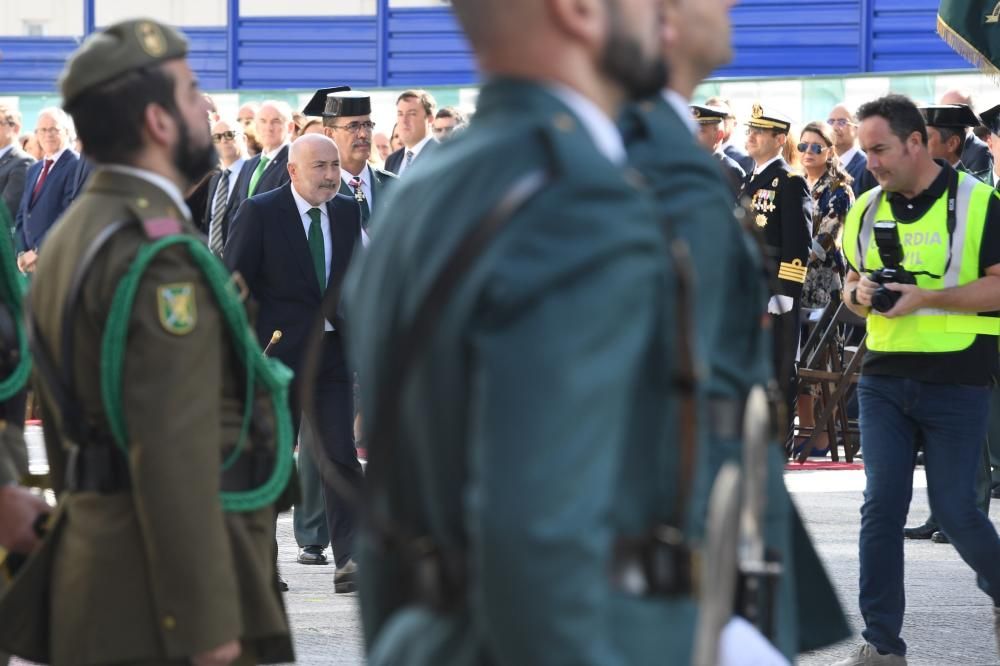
[101,236,293,512]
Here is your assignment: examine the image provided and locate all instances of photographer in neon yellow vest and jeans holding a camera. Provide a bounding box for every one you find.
[838,95,1000,666]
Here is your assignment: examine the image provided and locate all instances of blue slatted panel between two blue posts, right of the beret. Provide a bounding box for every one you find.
[237,16,378,90]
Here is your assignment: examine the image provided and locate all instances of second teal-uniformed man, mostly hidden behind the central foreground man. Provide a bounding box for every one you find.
[622,0,848,663]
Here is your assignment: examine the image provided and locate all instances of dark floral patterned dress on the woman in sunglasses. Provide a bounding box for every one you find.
[802,171,854,308]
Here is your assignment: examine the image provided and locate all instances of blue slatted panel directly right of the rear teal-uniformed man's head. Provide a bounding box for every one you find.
[715,0,862,77]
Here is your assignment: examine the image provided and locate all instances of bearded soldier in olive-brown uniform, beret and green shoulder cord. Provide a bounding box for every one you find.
[0,19,294,666]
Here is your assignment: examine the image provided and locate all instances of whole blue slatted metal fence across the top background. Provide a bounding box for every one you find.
[0,0,969,93]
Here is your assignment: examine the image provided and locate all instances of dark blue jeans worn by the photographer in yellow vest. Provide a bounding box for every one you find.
[858,375,1000,655]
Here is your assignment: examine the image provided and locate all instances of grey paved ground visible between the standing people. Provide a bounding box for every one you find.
[278,464,1000,666]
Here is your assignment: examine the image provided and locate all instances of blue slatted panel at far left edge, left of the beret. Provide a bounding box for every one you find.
[0,37,79,93]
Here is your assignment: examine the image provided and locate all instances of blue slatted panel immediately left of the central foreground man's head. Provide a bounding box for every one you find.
[382,9,479,88]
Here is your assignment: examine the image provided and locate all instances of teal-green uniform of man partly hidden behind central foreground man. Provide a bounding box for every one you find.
[623,96,849,663]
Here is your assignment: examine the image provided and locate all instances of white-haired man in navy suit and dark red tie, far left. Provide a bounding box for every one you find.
[14,107,80,273]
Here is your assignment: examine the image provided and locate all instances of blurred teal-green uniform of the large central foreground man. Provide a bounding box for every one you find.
[346,79,693,666]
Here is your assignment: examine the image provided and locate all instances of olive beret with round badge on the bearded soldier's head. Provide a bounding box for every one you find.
[59,19,188,106]
